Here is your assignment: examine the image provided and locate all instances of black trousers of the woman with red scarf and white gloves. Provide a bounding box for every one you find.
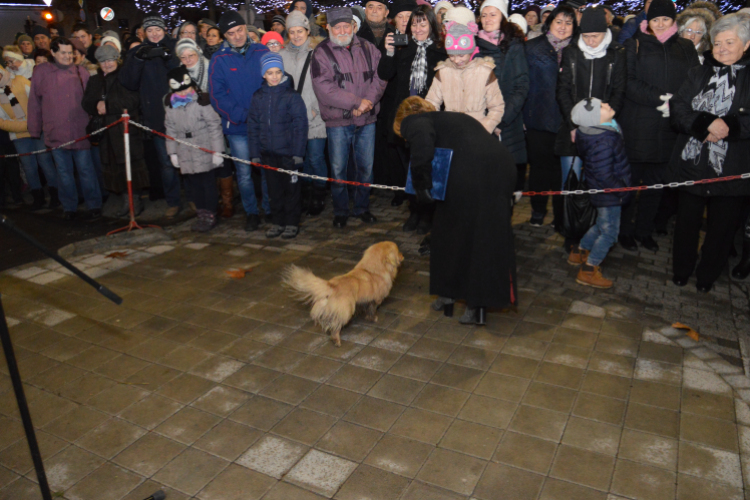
[620,163,668,238]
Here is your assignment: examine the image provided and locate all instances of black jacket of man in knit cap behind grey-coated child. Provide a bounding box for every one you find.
[118,35,180,132]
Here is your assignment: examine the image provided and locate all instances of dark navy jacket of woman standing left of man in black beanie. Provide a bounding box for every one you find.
[523,36,562,134]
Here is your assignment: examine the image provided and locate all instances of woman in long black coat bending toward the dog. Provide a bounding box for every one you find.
[396,97,518,324]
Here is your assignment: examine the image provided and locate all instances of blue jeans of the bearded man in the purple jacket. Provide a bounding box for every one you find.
[326,123,375,216]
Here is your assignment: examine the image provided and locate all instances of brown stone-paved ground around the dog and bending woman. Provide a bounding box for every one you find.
[0,197,750,500]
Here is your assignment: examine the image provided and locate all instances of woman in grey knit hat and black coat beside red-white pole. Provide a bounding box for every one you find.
[81,47,149,216]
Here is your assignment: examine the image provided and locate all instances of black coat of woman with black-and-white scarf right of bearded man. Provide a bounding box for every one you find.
[378,39,448,142]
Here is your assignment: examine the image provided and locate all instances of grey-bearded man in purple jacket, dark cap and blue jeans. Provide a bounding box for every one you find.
[310,7,386,228]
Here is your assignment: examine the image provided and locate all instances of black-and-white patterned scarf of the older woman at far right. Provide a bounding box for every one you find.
[682,64,744,176]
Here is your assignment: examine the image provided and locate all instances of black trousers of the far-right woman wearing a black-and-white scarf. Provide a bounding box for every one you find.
[672,191,743,285]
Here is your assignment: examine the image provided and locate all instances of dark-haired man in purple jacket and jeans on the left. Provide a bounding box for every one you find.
[27,38,102,220]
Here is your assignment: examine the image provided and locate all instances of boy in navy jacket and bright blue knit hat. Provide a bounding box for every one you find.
[247,52,307,239]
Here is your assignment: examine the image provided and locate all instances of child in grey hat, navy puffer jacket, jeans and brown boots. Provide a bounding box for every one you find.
[568,98,631,288]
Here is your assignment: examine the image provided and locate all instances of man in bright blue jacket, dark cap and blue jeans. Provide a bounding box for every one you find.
[208,11,268,231]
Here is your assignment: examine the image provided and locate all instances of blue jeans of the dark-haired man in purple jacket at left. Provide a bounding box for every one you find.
[52,149,102,212]
